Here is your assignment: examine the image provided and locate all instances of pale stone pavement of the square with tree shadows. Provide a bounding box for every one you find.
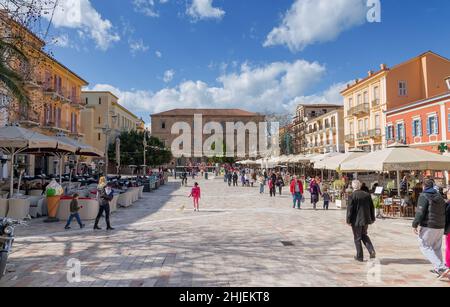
[0,179,448,287]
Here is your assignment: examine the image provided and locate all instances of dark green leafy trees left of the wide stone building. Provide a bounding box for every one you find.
[108,130,172,166]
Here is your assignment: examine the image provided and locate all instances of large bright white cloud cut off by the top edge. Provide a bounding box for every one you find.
[264,0,367,51]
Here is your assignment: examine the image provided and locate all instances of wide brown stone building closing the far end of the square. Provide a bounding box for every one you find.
[151,109,265,165]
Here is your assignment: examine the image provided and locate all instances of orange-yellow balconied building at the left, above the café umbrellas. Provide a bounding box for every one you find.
[0,12,88,175]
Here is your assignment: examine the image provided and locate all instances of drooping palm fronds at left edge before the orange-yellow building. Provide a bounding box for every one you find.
[0,39,30,106]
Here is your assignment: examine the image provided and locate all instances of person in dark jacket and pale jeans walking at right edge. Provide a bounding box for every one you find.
[412,179,449,278]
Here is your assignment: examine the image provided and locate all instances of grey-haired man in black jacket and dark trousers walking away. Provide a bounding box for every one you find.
[347,180,376,262]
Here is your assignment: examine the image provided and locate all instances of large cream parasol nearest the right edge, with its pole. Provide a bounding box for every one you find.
[341,144,450,194]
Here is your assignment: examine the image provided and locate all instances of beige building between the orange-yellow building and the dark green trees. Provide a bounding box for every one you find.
[81,91,145,160]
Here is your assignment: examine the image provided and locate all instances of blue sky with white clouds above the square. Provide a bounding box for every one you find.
[34,0,450,122]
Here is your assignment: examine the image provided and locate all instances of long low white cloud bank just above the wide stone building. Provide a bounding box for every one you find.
[88,60,340,117]
